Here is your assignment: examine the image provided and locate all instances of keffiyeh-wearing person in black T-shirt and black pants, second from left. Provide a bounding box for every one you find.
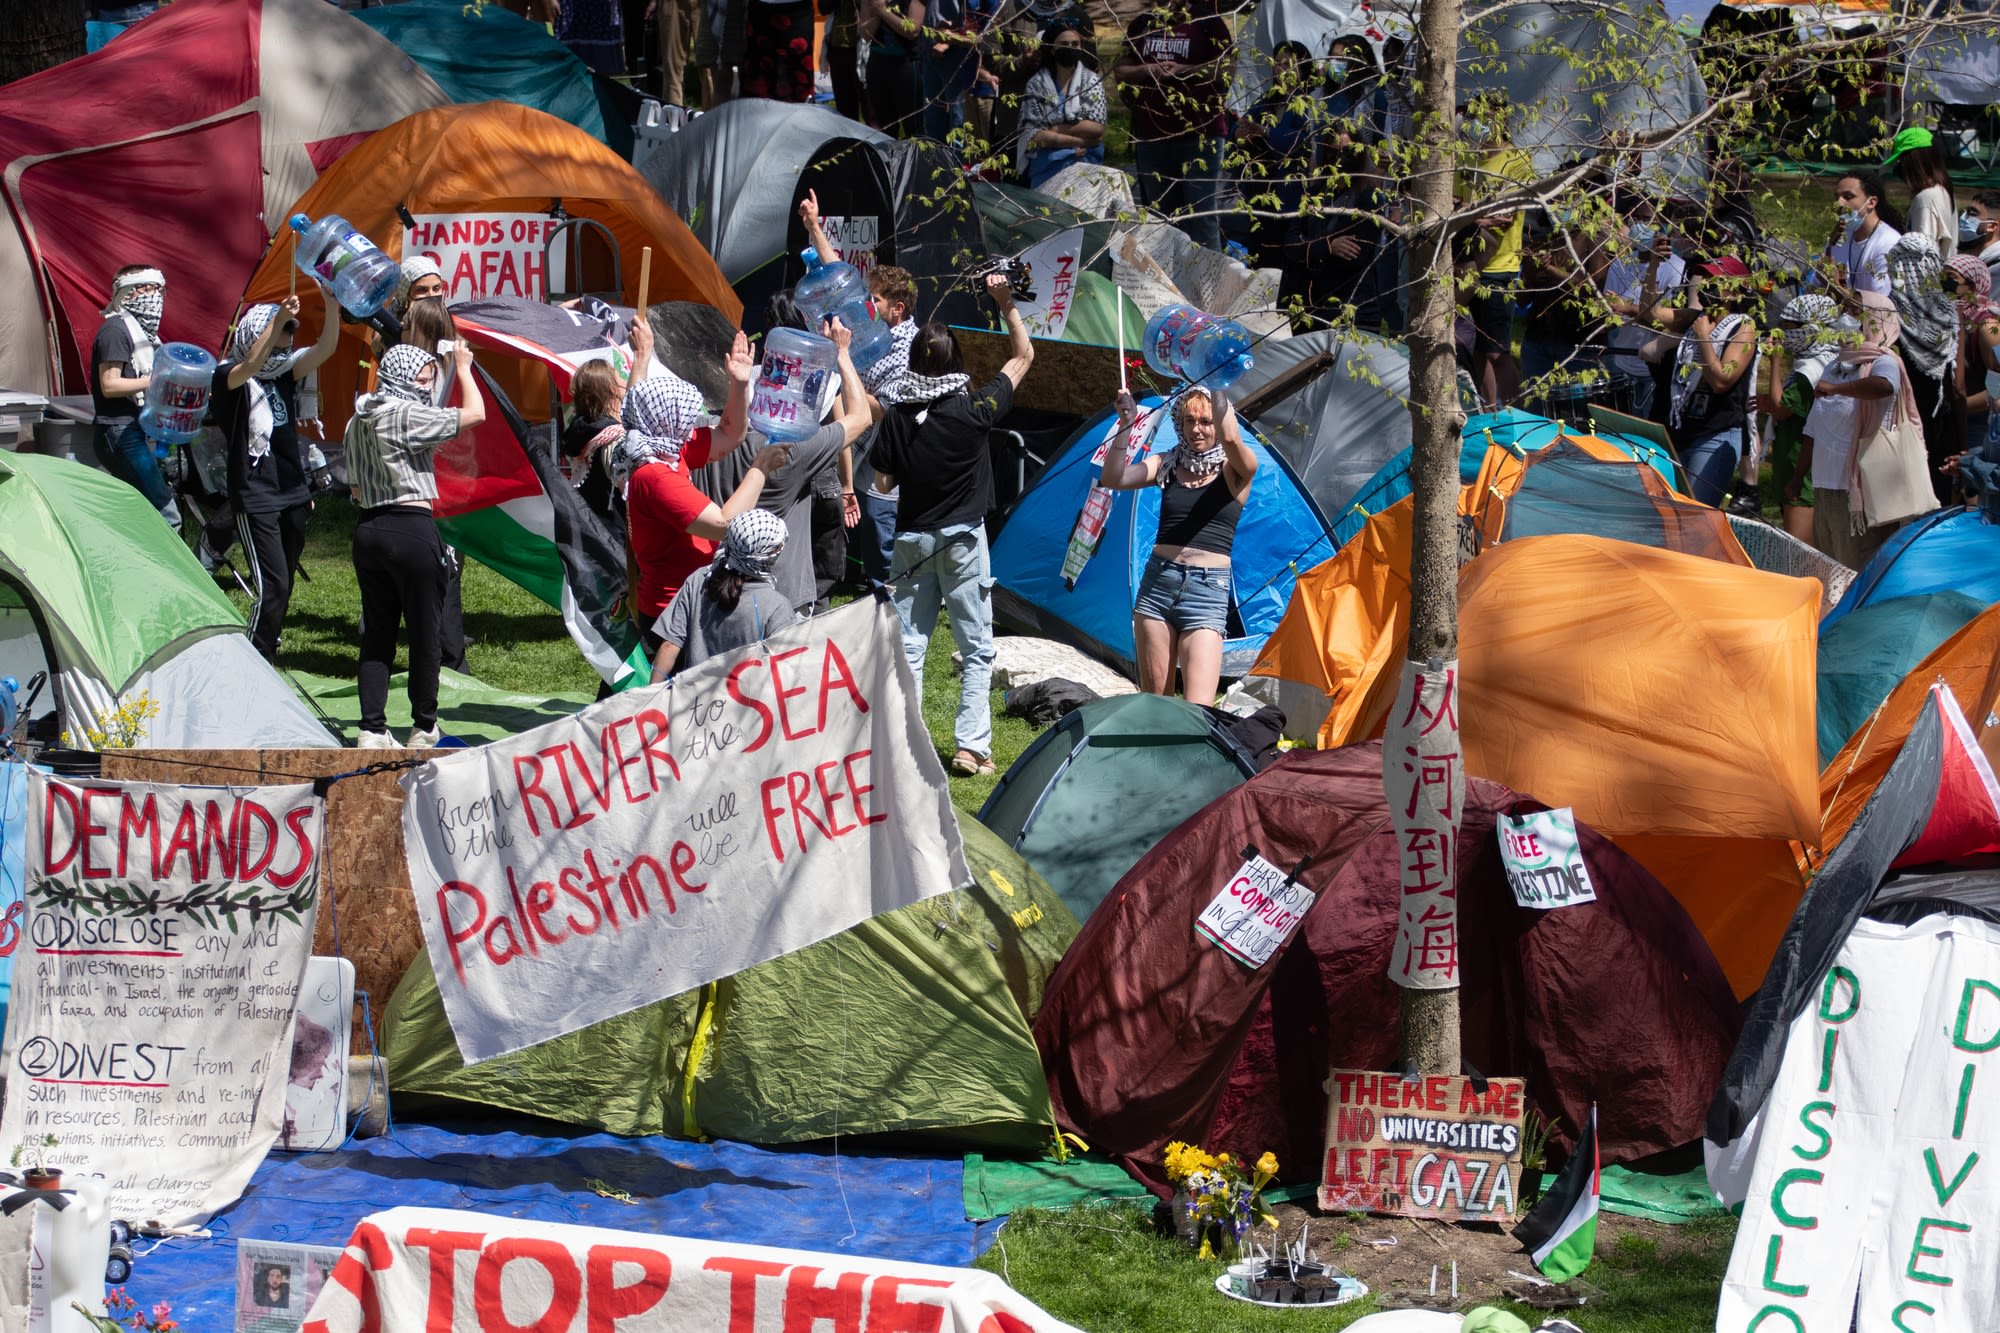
[204,296,340,662]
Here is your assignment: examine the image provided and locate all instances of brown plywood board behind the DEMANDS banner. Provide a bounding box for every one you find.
[102,749,424,1055]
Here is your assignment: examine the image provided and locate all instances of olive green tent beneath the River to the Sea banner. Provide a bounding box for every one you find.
[382,819,1078,1147]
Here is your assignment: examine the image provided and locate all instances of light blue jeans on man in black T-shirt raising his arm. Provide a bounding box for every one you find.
[894,522,994,755]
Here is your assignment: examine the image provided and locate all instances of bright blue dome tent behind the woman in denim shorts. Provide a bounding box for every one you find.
[992,398,1334,675]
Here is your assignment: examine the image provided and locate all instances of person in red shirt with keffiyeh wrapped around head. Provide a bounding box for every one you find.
[612,332,790,656]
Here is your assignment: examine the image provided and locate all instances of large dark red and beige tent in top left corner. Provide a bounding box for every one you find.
[0,0,450,394]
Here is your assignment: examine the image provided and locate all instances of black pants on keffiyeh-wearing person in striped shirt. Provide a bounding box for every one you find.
[354,504,444,731]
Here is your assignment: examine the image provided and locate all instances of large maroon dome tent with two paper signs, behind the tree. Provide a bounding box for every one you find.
[1034,743,1740,1193]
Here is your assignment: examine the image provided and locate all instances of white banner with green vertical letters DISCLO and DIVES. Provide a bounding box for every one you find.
[1716,915,2000,1333]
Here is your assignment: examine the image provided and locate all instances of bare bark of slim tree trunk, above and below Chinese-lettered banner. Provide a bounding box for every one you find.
[1402,0,1464,1075]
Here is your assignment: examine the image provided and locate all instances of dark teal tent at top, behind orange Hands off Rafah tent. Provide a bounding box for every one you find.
[354,0,632,160]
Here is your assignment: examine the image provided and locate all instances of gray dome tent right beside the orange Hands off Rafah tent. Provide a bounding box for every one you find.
[640,98,890,282]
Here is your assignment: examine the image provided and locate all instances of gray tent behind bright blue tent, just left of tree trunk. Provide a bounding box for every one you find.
[1230,328,1410,520]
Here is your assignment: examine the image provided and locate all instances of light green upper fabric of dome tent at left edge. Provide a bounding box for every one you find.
[0,454,244,695]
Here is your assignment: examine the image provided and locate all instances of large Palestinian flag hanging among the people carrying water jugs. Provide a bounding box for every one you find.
[434,358,650,689]
